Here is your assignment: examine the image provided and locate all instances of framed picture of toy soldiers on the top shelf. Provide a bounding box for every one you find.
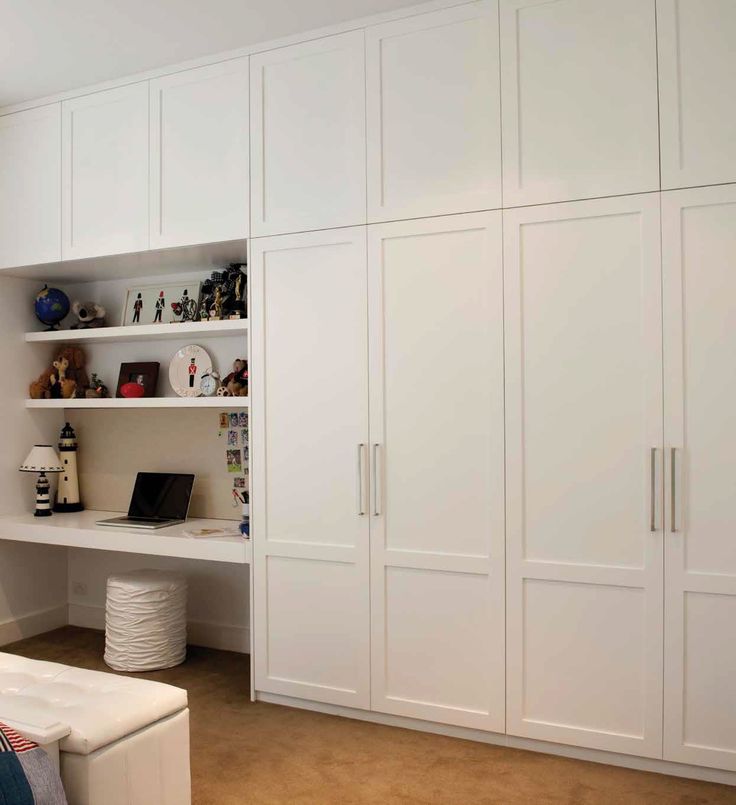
[120,281,202,327]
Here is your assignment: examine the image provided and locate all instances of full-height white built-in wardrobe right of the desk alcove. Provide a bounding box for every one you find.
[250,0,736,770]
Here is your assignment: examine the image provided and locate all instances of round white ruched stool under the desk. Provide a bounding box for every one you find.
[105,570,187,672]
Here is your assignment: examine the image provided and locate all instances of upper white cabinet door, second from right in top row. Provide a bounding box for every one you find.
[500,0,659,207]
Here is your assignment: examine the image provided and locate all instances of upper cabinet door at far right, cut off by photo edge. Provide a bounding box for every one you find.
[657,0,736,188]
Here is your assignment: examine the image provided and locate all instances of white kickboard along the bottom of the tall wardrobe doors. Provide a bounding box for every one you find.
[256,691,736,786]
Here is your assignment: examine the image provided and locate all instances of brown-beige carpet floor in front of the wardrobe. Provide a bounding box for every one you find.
[2,626,736,805]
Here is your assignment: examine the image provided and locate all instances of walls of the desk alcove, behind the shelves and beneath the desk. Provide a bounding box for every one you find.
[0,268,249,651]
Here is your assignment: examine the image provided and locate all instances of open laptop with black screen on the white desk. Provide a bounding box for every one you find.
[97,472,194,529]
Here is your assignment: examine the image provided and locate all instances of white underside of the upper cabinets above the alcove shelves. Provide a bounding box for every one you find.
[0,240,248,284]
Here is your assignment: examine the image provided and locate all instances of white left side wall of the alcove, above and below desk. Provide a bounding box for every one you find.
[0,278,67,645]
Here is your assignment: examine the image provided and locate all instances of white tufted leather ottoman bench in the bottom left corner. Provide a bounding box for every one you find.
[0,653,191,805]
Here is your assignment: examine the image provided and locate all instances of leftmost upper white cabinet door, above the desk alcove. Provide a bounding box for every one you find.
[0,103,61,268]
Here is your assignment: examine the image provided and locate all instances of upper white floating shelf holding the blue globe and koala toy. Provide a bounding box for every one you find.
[26,319,248,344]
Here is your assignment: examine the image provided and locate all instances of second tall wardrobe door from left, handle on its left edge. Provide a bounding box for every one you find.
[368,213,505,732]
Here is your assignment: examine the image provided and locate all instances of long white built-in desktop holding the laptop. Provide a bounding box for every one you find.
[0,511,251,565]
